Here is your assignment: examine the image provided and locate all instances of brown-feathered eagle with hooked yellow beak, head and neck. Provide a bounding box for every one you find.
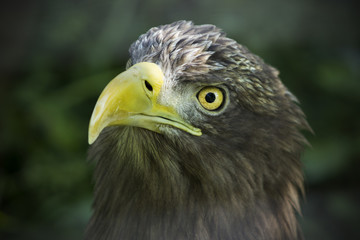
[85,21,310,240]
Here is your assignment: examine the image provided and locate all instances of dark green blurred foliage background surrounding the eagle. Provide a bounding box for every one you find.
[0,0,360,240]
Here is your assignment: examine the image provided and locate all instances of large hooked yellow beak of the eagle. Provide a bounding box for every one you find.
[89,62,202,144]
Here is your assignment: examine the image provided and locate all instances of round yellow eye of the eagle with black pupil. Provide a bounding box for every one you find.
[197,87,224,111]
